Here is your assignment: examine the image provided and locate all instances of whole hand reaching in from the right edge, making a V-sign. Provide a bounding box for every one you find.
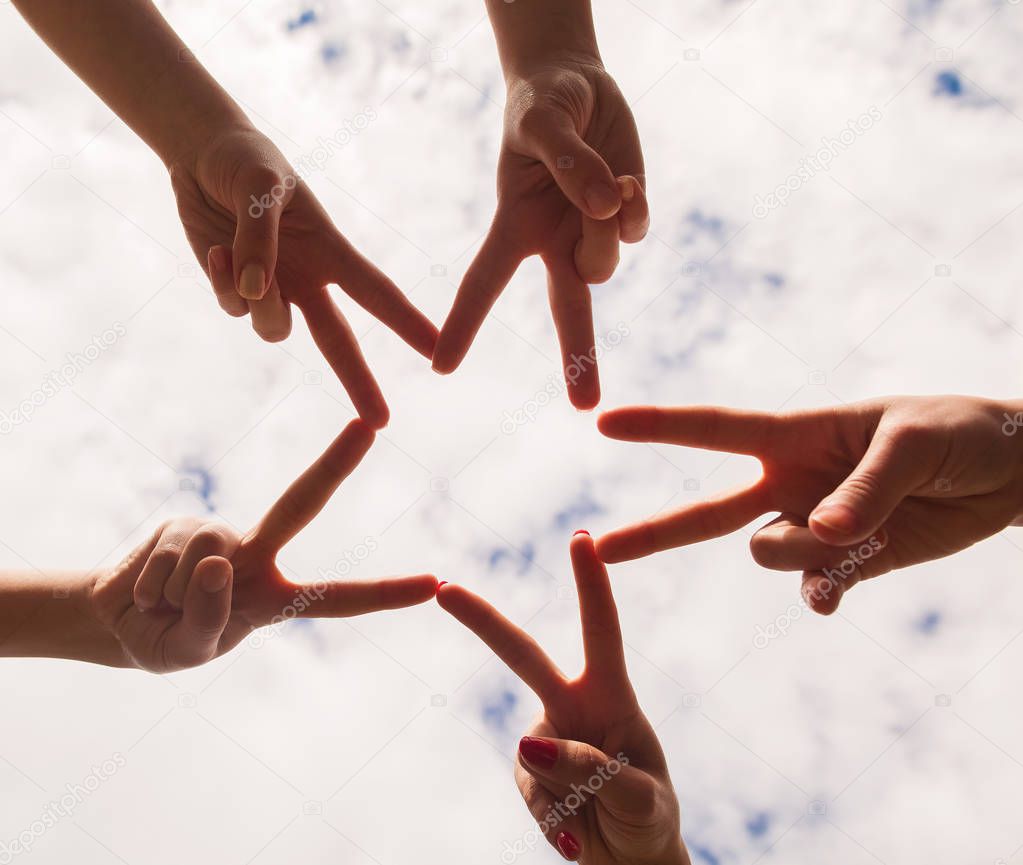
[596,397,1023,614]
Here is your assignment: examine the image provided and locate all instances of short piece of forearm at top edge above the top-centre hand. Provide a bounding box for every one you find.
[486,0,601,81]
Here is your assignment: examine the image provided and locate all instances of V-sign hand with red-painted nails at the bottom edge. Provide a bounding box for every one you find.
[437,532,690,865]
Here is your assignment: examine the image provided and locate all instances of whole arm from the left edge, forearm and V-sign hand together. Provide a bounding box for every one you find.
[0,420,437,673]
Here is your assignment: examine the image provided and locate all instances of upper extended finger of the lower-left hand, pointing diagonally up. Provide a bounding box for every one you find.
[252,418,373,552]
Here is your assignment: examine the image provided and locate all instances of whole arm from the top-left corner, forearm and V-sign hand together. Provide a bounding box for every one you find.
[15,0,437,427]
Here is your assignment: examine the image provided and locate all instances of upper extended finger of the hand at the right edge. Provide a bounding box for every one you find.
[596,406,783,456]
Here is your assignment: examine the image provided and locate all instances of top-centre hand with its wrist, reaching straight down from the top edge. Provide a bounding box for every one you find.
[434,0,650,409]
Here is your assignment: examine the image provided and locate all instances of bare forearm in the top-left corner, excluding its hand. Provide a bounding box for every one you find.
[13,0,248,165]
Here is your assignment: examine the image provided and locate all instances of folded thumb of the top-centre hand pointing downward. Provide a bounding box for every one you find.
[523,112,622,219]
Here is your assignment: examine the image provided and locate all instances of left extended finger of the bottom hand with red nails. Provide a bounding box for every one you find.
[437,583,565,705]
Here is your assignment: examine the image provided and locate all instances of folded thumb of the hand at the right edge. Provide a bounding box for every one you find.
[807,427,933,545]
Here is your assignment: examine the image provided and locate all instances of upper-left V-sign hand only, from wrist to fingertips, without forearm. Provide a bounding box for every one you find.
[171,126,437,427]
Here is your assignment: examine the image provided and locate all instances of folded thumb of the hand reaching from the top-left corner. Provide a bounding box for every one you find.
[233,167,290,301]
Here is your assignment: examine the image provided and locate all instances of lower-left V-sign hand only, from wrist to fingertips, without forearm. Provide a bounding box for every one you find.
[91,420,437,673]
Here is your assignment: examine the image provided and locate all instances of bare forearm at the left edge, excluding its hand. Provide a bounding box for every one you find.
[0,571,129,667]
